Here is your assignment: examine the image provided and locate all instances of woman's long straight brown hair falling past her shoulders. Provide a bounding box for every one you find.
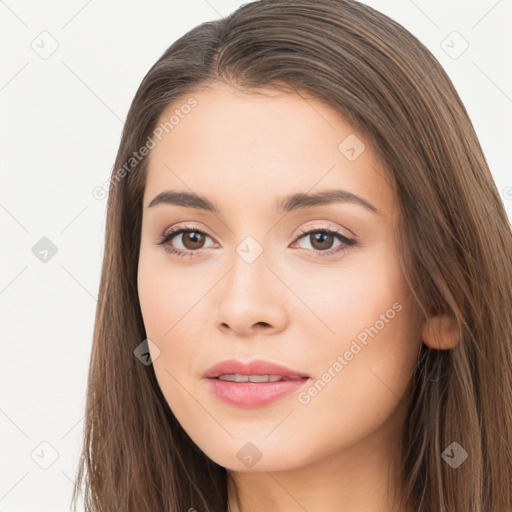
[72,0,512,512]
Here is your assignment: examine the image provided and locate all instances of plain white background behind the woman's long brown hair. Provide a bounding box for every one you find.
[0,0,512,512]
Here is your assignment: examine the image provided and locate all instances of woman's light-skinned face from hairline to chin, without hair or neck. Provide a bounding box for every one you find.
[138,85,421,471]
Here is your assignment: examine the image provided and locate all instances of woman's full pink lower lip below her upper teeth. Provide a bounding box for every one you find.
[207,378,310,407]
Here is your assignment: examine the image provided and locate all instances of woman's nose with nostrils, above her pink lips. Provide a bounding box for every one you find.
[216,246,287,337]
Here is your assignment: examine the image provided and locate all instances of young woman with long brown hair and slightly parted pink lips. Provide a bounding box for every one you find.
[74,0,512,512]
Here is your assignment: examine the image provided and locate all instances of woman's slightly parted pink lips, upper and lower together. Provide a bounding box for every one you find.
[203,359,310,407]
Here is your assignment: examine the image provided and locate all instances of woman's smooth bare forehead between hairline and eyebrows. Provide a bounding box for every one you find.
[144,84,392,216]
